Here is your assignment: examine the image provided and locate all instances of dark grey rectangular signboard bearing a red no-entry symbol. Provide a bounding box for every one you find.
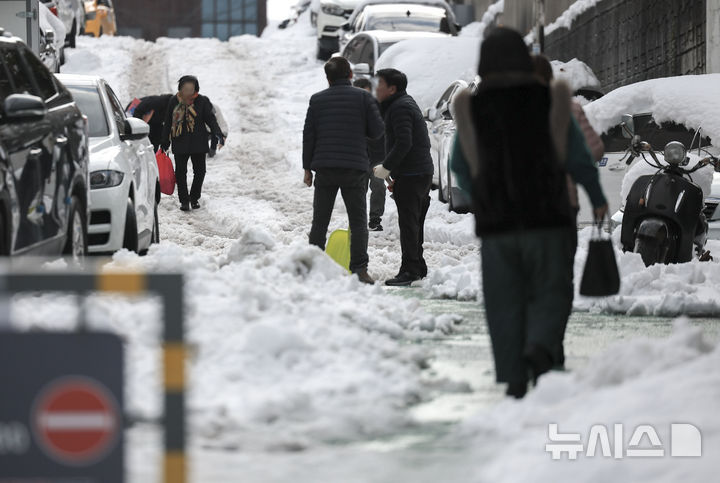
[0,333,124,483]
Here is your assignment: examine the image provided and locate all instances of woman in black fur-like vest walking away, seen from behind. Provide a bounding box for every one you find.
[451,28,607,398]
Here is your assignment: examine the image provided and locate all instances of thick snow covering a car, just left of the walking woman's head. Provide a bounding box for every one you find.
[375,36,480,109]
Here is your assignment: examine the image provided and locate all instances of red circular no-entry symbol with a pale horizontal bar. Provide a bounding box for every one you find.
[33,377,120,466]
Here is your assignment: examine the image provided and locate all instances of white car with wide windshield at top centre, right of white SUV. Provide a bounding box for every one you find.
[340,0,460,50]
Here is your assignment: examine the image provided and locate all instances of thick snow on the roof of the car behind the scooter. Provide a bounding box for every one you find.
[585,74,720,146]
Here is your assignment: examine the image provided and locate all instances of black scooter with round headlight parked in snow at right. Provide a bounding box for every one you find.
[621,116,720,266]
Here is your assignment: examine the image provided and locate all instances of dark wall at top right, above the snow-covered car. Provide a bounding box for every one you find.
[545,0,714,90]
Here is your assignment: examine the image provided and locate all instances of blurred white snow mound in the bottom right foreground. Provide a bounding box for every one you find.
[442,321,720,483]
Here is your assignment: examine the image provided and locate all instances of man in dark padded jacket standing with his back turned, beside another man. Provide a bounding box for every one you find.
[303,57,383,284]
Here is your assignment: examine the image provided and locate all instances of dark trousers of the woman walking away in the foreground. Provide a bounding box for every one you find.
[481,228,577,390]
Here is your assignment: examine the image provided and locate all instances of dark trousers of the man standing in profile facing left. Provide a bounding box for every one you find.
[393,174,432,277]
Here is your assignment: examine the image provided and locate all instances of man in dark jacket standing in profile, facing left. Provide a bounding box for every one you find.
[375,69,434,286]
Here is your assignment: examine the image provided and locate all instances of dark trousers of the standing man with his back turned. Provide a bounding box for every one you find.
[310,169,369,273]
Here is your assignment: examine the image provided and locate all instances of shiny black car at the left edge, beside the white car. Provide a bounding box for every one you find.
[0,29,89,261]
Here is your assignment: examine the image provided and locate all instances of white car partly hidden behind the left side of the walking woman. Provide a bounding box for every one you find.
[424,80,478,213]
